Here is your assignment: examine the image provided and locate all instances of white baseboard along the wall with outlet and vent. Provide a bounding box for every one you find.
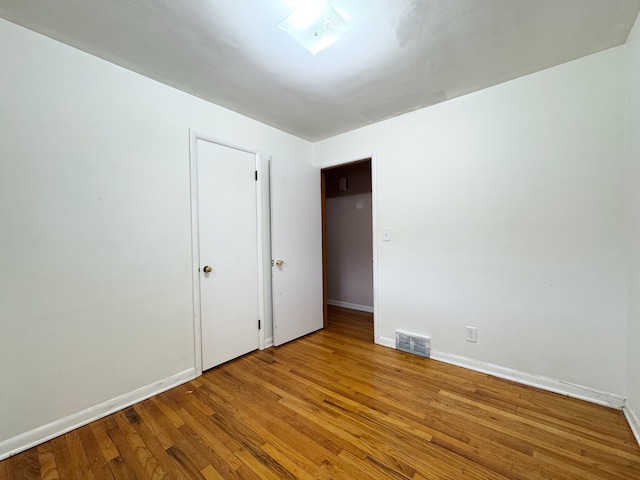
[379,337,625,410]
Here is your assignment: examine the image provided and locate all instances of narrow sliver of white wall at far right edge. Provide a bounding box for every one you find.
[625,11,640,442]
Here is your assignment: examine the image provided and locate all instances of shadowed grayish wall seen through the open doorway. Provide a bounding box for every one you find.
[326,193,373,309]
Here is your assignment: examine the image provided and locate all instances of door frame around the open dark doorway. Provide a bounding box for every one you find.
[316,151,381,344]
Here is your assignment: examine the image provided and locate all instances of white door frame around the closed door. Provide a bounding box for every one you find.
[189,129,270,377]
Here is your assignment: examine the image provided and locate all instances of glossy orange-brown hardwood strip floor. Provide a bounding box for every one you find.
[0,307,640,480]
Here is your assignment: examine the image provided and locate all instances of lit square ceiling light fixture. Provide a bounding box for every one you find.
[278,0,351,55]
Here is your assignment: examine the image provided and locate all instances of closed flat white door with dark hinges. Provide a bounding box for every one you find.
[196,139,259,370]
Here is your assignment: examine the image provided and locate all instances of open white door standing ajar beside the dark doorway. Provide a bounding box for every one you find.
[271,159,323,346]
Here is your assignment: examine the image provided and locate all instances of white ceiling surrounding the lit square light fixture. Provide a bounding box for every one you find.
[0,0,640,141]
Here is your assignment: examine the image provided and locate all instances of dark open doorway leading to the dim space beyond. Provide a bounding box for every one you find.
[321,158,374,341]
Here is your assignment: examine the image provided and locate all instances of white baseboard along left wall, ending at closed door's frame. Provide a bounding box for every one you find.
[0,368,196,460]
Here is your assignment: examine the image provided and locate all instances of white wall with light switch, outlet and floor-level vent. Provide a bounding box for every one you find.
[314,47,626,403]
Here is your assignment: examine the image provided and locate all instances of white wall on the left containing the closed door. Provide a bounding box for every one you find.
[0,20,311,457]
